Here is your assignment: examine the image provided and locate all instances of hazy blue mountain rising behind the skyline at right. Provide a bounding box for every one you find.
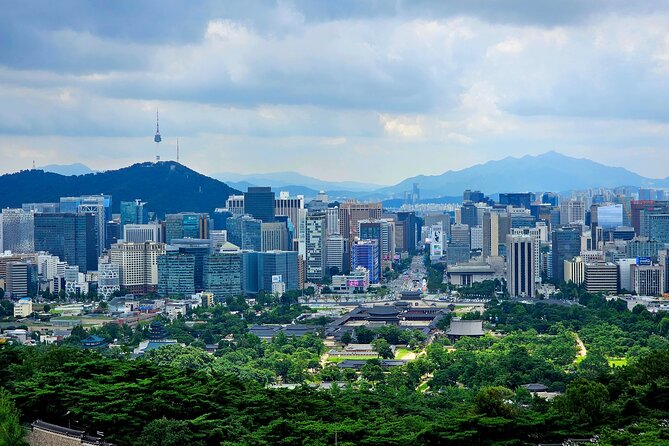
[376,152,656,198]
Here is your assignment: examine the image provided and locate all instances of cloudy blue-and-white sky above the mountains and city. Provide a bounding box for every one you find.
[0,0,669,184]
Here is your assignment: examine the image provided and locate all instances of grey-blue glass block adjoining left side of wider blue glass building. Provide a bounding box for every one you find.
[204,251,242,301]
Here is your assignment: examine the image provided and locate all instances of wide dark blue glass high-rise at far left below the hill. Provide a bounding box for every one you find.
[34,213,99,271]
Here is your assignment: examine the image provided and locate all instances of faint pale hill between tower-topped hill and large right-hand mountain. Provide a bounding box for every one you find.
[212,172,381,192]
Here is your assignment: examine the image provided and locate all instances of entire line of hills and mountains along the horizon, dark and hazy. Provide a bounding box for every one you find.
[9,152,669,207]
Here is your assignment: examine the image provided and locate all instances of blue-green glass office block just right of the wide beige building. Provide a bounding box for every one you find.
[158,249,195,296]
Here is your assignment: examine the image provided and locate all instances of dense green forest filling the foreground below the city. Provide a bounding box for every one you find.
[0,296,669,445]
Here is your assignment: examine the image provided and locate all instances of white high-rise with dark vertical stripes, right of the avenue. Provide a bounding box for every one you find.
[506,234,538,297]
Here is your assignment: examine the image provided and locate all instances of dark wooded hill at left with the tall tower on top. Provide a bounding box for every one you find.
[0,161,240,216]
